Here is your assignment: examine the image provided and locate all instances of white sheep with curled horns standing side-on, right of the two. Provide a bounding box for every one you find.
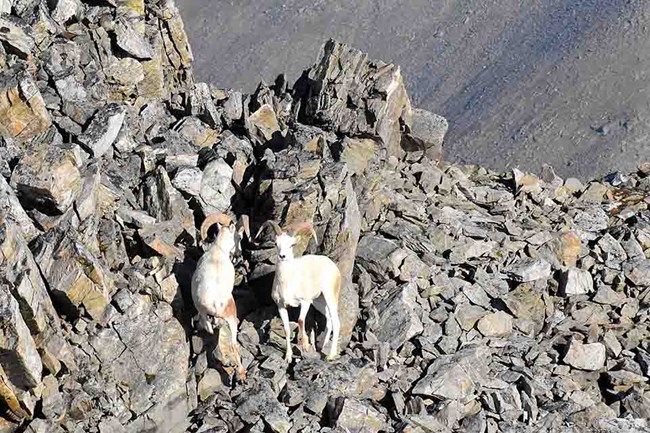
[255,220,341,363]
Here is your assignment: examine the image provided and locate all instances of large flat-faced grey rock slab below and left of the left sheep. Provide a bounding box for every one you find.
[89,290,196,432]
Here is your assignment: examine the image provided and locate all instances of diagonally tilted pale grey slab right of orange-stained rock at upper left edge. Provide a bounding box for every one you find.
[79,104,126,158]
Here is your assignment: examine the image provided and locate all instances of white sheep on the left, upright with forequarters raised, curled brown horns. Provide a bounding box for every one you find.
[192,213,250,380]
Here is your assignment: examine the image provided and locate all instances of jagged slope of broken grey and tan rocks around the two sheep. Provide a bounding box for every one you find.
[0,0,650,433]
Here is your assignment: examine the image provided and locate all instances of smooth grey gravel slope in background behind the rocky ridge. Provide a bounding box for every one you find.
[179,0,650,178]
